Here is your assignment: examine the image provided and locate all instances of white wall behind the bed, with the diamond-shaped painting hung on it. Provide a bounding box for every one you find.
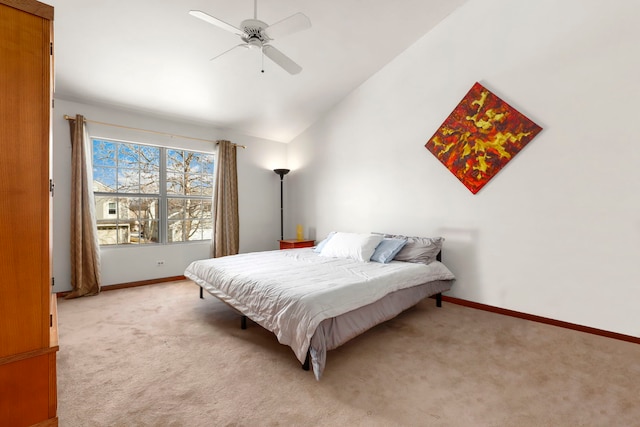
[288,0,640,337]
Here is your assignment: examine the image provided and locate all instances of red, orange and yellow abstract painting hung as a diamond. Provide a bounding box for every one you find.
[425,83,542,194]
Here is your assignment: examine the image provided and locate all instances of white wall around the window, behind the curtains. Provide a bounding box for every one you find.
[53,99,286,292]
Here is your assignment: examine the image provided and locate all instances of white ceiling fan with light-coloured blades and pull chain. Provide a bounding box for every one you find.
[189,0,311,74]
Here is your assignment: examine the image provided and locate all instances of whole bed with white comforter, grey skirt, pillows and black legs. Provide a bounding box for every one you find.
[184,232,455,380]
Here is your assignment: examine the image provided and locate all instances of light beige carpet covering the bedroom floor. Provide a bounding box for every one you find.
[58,281,640,427]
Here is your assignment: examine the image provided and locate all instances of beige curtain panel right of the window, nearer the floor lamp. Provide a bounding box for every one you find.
[211,141,240,258]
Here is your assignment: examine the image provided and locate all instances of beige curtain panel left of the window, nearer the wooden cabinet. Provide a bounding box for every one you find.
[67,114,100,298]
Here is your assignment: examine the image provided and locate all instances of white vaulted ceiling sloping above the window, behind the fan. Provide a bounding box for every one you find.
[42,0,467,142]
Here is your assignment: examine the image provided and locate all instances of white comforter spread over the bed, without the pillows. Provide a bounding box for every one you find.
[184,248,454,363]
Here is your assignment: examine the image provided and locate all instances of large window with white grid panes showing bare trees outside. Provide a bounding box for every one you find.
[92,139,214,245]
